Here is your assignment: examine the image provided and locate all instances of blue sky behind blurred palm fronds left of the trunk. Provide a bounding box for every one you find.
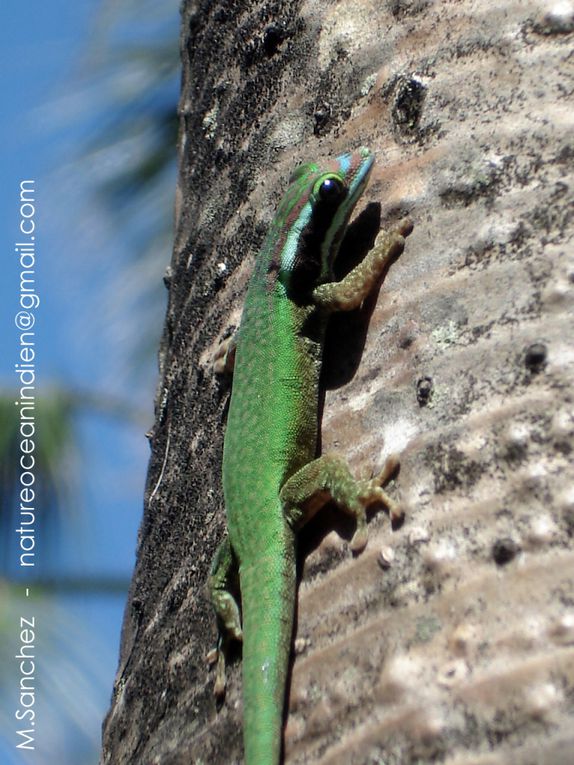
[0,0,178,765]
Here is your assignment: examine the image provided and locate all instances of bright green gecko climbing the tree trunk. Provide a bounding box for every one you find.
[209,148,412,765]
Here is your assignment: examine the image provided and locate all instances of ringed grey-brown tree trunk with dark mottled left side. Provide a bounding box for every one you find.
[102,0,574,765]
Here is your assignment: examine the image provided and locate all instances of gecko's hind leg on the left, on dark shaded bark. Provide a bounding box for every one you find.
[208,537,243,698]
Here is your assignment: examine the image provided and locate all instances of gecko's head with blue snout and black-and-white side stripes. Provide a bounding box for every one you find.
[279,148,375,298]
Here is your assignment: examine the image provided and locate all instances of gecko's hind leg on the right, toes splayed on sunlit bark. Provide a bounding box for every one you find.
[280,454,403,552]
